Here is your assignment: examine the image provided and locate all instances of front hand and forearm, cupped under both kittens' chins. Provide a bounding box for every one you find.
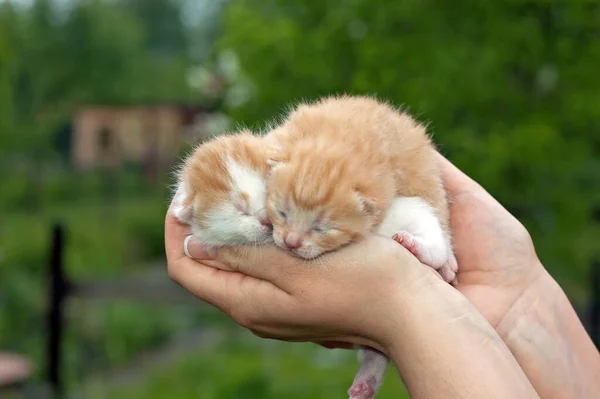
[166,175,538,398]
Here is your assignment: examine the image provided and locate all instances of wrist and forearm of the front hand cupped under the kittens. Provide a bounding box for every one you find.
[380,277,538,398]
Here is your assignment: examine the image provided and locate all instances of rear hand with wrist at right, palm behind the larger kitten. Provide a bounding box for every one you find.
[440,156,600,399]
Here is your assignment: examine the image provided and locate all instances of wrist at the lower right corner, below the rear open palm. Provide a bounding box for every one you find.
[496,264,600,399]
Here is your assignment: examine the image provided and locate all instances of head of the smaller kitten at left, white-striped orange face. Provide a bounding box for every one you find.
[173,131,272,247]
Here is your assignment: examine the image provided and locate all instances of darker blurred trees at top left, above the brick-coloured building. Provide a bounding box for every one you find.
[0,0,202,163]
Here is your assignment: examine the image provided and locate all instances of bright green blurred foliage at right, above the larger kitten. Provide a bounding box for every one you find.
[219,0,600,299]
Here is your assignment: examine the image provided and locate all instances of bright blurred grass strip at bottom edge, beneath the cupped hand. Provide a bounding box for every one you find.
[90,337,408,399]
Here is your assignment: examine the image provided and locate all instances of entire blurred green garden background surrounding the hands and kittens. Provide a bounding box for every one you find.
[0,0,600,399]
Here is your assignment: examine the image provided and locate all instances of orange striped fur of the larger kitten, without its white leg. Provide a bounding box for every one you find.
[267,96,449,263]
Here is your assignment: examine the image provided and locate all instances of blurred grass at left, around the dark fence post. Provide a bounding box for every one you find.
[0,188,190,390]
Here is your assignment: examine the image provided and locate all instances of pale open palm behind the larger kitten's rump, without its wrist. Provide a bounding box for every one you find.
[442,159,544,327]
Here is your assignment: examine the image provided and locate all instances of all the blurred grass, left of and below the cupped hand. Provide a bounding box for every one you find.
[0,165,584,399]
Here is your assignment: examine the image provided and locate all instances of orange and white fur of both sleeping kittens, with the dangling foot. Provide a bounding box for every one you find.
[173,96,456,399]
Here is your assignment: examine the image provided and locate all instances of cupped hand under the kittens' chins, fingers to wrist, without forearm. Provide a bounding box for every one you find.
[165,193,450,352]
